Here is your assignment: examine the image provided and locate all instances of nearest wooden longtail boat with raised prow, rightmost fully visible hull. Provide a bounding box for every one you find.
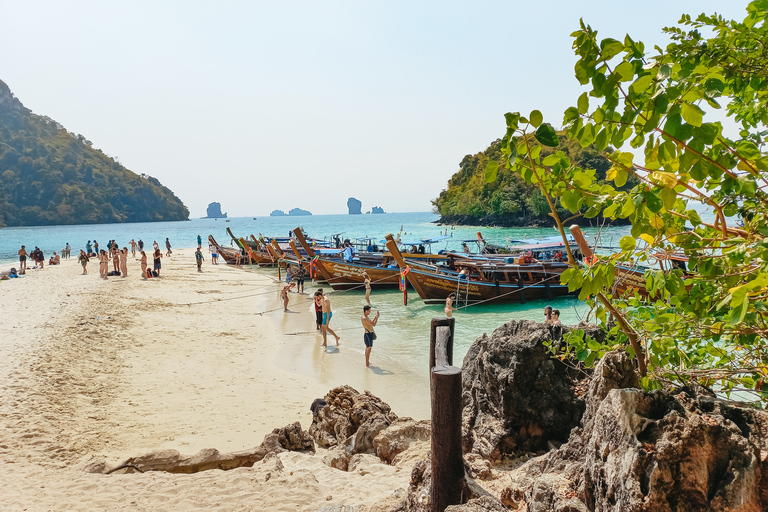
[386,234,572,305]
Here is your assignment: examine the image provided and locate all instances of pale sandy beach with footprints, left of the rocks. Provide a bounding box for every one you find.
[0,250,420,511]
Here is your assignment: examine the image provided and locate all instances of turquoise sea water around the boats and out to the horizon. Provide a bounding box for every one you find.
[0,212,629,382]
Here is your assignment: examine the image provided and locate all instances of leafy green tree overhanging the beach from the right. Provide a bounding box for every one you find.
[489,0,768,399]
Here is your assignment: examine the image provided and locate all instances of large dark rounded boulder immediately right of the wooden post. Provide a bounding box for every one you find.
[462,320,584,460]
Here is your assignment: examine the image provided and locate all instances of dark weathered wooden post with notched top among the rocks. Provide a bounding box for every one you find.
[429,318,464,512]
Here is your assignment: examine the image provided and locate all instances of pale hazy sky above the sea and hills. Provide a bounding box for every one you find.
[0,0,747,217]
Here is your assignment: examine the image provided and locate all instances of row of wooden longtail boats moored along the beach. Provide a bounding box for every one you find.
[208,226,684,306]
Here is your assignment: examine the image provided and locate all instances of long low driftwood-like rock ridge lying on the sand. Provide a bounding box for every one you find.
[91,421,315,473]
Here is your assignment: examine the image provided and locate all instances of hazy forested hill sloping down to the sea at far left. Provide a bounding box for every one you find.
[0,81,189,226]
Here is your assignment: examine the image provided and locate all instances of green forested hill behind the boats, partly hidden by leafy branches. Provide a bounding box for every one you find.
[432,135,635,226]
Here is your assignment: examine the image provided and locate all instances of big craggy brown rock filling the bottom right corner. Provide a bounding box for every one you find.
[492,352,768,512]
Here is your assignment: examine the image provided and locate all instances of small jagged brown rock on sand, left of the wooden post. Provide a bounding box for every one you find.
[309,386,397,454]
